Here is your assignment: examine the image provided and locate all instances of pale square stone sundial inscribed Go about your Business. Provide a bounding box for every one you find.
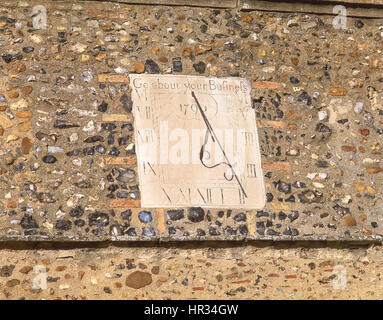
[130,74,265,209]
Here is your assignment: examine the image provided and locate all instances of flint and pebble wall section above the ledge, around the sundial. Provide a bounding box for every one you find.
[0,1,383,242]
